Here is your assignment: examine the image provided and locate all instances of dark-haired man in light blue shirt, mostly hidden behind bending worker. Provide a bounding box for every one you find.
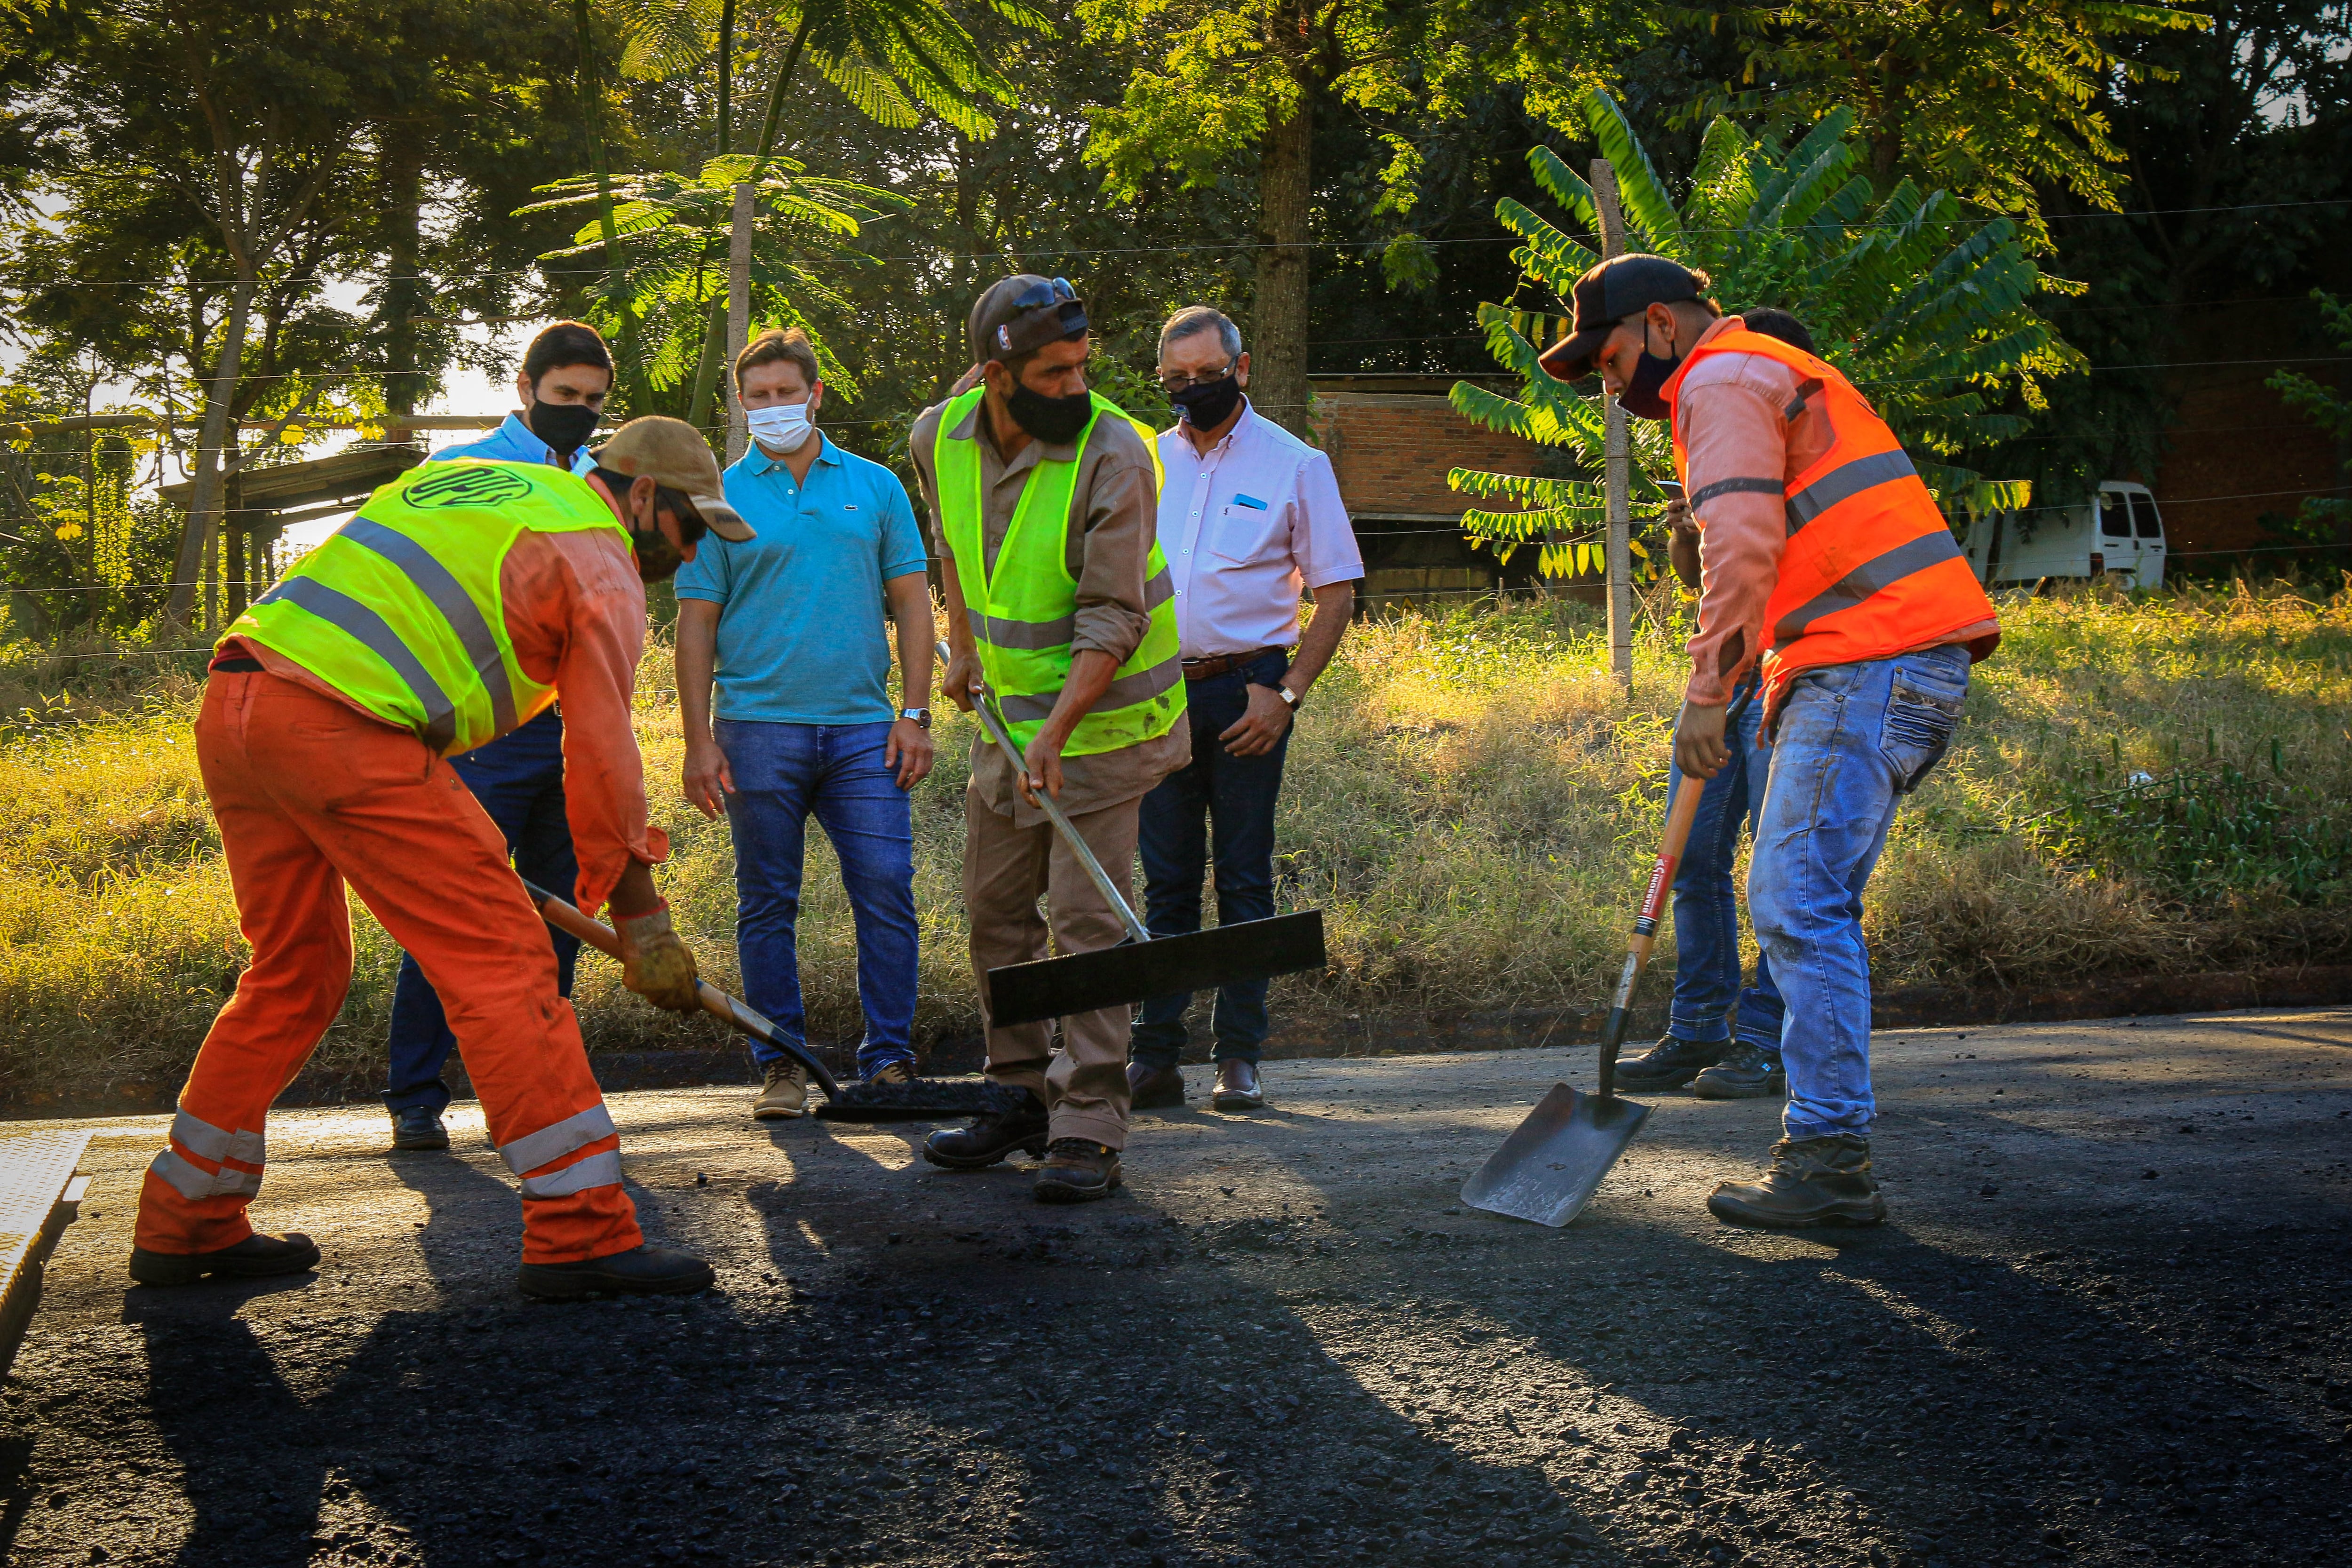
[383,322,612,1150]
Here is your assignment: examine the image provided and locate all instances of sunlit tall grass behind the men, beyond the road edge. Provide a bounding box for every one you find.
[0,588,2352,1100]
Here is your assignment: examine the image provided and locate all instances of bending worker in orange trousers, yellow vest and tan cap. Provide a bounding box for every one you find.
[129,418,750,1295]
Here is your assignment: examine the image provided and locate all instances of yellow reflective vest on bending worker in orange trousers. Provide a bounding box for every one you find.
[221,458,628,757]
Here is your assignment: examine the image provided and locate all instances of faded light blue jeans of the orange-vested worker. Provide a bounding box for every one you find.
[1748,644,1969,1138]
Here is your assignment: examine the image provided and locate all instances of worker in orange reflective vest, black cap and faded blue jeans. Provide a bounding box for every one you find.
[1543,256,2002,1225]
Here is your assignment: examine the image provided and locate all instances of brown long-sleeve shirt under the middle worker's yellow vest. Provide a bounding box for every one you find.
[908,392,1192,828]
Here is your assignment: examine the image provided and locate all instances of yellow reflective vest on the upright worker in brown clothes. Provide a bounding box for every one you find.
[931,388,1183,757]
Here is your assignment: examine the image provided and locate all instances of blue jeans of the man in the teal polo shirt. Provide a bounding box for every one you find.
[715,719,922,1077]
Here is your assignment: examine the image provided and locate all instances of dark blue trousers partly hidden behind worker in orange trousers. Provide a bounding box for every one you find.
[383,708,581,1117]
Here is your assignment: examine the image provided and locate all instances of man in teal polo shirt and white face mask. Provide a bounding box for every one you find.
[677,329,934,1122]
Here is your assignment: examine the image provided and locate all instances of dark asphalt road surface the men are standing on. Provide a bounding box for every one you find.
[0,1011,2352,1568]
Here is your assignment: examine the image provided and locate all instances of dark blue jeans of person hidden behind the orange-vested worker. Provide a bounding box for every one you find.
[1665,675,1783,1058]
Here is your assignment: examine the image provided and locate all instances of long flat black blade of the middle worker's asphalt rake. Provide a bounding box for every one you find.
[988,910,1327,1030]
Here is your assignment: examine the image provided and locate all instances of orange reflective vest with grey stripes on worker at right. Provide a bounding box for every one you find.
[1663,329,1994,715]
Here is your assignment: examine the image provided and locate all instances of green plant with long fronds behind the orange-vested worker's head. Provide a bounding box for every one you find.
[1451,89,2084,576]
